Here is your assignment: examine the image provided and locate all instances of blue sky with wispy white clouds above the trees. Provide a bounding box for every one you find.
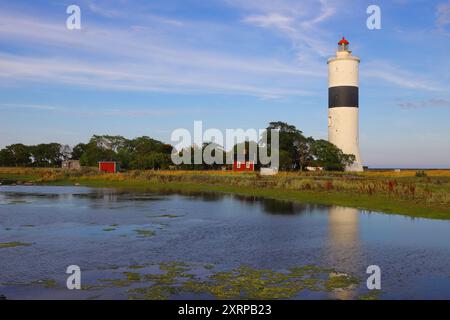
[0,0,450,167]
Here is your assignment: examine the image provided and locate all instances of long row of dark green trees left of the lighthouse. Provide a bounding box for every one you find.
[0,121,355,171]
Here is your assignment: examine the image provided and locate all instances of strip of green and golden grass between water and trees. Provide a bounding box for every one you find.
[0,168,450,220]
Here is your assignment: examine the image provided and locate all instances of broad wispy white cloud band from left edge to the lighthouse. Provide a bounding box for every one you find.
[0,12,320,98]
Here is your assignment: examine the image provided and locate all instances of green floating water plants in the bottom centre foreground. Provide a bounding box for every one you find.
[92,262,359,300]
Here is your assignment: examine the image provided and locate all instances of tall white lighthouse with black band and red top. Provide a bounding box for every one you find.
[328,37,363,171]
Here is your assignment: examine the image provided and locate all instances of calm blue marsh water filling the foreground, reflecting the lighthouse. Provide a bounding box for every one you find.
[0,186,450,299]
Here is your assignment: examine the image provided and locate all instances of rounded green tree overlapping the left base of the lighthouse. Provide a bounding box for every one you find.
[311,140,356,171]
